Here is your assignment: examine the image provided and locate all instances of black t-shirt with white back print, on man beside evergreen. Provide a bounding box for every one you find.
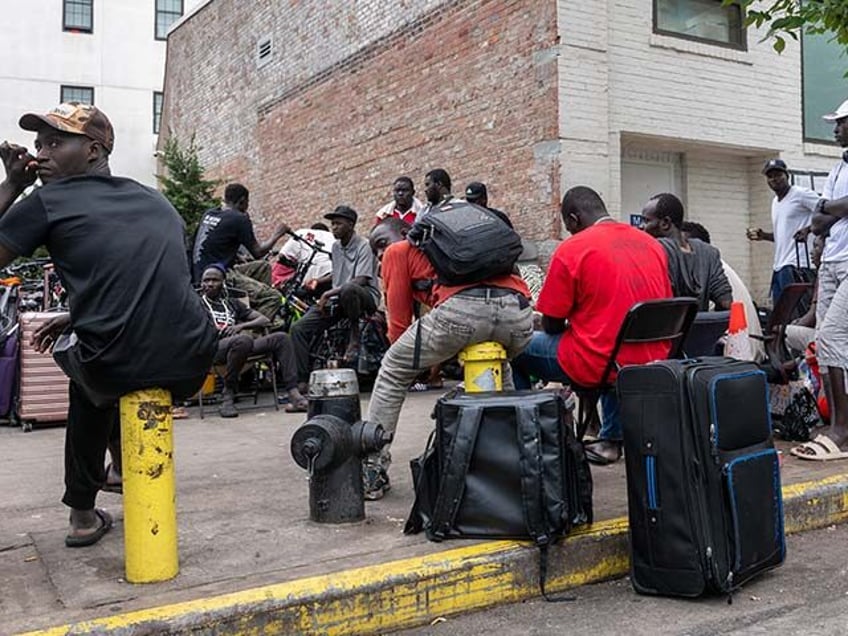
[191,208,256,281]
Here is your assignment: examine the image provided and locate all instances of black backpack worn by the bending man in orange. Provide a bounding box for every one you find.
[407,201,522,285]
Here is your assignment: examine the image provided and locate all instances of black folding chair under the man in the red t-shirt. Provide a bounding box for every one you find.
[572,298,698,440]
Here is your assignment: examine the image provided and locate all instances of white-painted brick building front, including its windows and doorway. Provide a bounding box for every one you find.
[558,0,848,301]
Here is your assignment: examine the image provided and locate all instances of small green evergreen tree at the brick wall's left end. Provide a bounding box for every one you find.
[157,135,223,237]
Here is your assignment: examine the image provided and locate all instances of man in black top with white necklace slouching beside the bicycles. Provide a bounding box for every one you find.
[201,265,307,417]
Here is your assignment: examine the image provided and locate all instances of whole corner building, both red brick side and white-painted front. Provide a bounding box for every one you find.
[163,0,848,300]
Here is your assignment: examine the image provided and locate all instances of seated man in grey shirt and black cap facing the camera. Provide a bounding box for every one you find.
[291,205,380,385]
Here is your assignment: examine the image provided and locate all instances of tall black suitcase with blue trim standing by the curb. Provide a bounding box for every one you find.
[617,358,786,597]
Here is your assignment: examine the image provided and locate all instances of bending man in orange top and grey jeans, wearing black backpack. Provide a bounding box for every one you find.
[364,201,533,500]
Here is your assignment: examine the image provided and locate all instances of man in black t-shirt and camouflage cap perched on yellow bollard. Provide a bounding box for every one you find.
[0,103,217,547]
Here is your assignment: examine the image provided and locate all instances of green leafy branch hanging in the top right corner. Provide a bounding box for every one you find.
[722,0,848,76]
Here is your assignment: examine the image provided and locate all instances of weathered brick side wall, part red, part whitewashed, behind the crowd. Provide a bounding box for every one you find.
[163,0,560,239]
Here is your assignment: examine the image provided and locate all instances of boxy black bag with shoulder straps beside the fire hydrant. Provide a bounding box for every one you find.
[404,391,592,595]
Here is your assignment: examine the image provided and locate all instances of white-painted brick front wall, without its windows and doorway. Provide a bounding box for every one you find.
[558,0,837,301]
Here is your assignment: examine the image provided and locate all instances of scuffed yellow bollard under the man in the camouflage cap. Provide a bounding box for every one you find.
[121,389,180,583]
